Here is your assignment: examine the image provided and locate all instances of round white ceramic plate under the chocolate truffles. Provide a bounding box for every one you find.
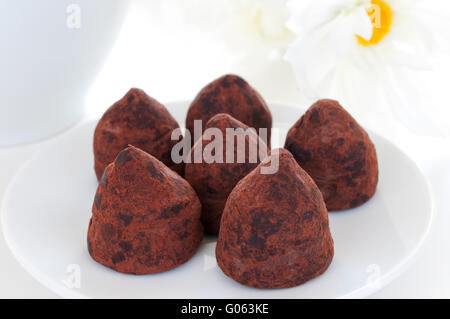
[2,103,433,298]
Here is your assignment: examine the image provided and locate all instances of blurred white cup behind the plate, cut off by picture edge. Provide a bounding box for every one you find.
[0,0,127,146]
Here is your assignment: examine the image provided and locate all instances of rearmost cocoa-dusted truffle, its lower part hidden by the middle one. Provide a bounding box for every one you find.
[186,75,272,145]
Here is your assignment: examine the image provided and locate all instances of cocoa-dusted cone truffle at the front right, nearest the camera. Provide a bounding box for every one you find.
[216,149,334,288]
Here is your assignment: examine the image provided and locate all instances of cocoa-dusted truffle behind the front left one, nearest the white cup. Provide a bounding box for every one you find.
[94,89,184,179]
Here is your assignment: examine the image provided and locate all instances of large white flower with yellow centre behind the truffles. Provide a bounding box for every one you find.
[286,0,450,134]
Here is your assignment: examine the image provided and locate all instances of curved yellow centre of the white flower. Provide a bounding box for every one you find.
[356,0,393,47]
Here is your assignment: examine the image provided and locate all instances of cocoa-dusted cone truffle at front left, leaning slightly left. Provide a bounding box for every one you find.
[88,147,203,275]
